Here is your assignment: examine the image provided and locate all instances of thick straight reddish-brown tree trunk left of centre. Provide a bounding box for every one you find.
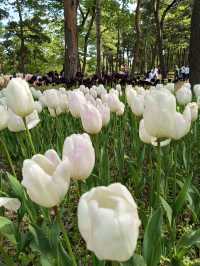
[64,0,78,81]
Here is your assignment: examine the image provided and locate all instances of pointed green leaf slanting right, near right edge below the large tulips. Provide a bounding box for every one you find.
[173,176,192,217]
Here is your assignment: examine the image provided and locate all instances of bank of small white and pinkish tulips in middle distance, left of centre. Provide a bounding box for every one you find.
[31,82,125,134]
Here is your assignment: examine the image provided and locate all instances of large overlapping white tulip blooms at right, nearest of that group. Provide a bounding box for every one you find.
[139,89,192,146]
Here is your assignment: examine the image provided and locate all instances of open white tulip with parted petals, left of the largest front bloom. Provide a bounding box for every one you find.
[22,150,71,208]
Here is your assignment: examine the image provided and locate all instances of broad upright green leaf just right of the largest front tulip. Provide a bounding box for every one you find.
[143,208,162,266]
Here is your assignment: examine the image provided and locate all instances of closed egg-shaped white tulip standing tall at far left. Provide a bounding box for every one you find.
[6,78,34,117]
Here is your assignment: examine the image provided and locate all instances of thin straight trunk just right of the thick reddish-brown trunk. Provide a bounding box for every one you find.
[96,0,101,77]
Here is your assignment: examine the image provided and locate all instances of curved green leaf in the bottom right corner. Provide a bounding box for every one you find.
[176,229,200,257]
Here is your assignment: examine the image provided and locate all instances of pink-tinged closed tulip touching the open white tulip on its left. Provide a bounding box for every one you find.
[63,133,95,180]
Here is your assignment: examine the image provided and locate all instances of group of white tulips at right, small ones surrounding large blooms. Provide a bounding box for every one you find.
[126,83,199,146]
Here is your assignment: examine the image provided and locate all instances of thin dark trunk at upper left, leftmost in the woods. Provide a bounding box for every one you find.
[16,0,25,73]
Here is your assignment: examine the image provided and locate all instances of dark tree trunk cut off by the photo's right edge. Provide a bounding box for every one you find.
[189,0,200,86]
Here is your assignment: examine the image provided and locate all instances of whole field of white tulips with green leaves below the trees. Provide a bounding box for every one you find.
[0,78,200,266]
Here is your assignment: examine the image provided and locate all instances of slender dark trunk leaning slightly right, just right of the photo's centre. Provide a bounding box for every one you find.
[131,0,142,77]
